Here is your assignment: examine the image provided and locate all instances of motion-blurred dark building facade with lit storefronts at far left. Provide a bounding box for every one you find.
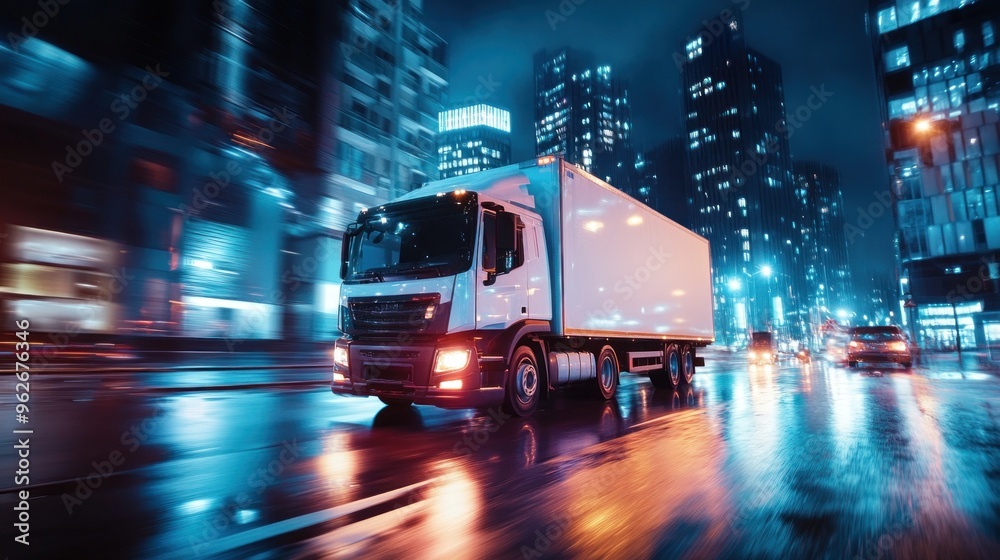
[0,0,340,343]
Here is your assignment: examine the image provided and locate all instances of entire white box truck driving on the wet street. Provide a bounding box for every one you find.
[331,157,714,416]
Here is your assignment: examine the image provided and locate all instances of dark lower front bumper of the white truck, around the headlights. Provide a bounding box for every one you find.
[330,339,504,408]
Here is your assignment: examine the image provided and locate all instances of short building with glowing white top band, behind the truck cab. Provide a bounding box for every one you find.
[438,104,511,179]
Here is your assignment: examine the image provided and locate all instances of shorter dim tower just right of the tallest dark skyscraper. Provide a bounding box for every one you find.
[792,161,855,325]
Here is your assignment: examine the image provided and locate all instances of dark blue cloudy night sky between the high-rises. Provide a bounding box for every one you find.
[424,0,893,287]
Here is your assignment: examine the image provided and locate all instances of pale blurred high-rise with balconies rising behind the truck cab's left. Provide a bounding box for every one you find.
[321,0,448,229]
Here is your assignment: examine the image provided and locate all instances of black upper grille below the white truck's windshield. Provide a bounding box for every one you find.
[348,294,441,333]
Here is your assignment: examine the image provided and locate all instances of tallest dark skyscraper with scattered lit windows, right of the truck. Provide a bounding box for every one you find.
[681,16,805,344]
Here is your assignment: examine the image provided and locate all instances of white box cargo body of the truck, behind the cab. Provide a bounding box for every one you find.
[536,163,714,343]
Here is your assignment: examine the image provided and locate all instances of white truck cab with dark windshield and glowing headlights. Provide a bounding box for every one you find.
[333,189,551,408]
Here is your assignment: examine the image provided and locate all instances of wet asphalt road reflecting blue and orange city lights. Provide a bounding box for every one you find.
[0,354,1000,558]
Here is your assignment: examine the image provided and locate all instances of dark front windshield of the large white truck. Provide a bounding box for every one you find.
[344,193,478,282]
